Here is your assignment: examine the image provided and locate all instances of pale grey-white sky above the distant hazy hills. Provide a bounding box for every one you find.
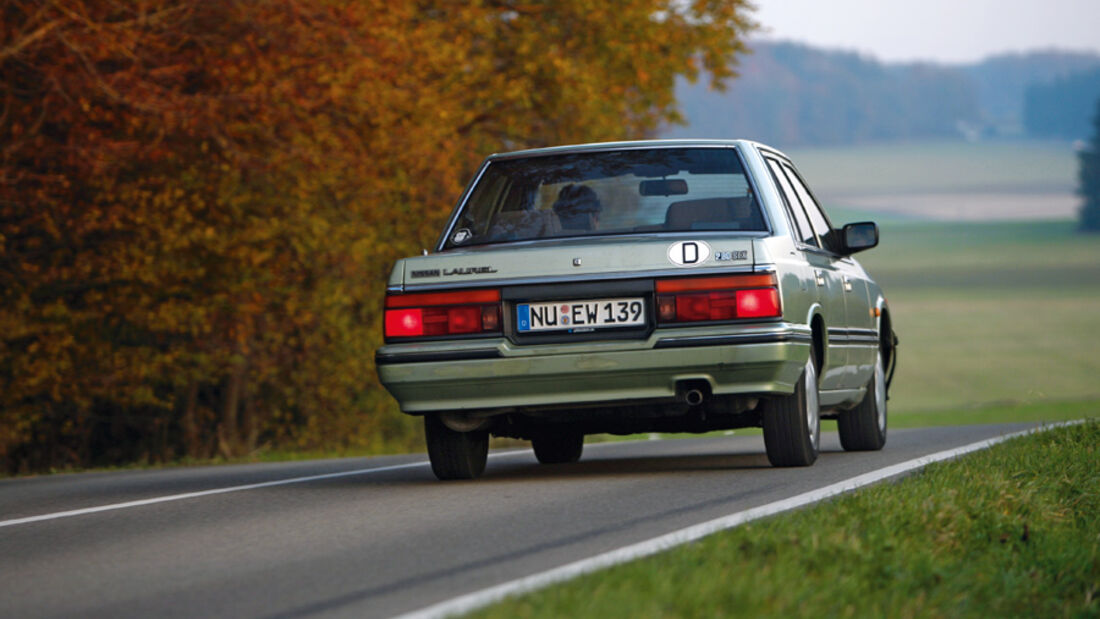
[752,0,1100,63]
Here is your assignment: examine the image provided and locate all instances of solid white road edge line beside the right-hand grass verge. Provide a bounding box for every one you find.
[396,421,1084,619]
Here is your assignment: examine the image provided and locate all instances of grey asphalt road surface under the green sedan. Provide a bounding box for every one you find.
[0,424,1029,617]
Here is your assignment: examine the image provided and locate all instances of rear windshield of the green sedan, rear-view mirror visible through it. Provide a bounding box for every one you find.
[444,148,767,248]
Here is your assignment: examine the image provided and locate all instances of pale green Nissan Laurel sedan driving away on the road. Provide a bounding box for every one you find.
[376,140,897,479]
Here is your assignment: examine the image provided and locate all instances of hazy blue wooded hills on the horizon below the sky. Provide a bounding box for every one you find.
[662,41,1100,146]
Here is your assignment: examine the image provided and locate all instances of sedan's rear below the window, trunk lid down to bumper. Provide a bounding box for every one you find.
[376,239,810,413]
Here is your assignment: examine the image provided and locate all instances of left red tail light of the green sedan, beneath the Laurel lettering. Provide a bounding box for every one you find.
[385,290,501,340]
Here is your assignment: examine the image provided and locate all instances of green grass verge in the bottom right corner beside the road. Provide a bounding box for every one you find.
[474,421,1100,618]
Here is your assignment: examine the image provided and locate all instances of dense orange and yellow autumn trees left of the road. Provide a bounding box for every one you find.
[0,0,750,469]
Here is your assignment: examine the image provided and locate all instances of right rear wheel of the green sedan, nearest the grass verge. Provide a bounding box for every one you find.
[761,351,821,466]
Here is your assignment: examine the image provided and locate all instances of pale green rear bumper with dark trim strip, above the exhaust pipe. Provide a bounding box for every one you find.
[375,322,811,414]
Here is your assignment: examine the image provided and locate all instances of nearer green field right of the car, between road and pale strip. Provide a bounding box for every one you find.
[860,217,1100,413]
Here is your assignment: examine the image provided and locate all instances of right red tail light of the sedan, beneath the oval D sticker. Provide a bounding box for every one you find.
[657,275,783,323]
